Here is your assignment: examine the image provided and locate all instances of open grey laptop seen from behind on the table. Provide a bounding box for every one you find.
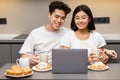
[52,49,88,74]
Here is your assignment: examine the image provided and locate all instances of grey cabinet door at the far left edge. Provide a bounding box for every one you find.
[0,44,11,67]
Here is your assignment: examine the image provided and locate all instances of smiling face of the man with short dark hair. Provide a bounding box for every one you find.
[49,9,66,30]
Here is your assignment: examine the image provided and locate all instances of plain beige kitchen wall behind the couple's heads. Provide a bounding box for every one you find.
[0,0,120,34]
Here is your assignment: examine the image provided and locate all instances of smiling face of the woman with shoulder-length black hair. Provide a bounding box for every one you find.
[74,11,90,30]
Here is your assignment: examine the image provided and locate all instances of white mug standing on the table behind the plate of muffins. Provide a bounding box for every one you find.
[16,58,30,67]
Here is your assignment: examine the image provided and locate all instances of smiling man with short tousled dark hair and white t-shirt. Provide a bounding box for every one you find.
[19,1,71,64]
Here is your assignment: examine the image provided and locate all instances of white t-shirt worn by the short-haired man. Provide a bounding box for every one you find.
[19,26,69,63]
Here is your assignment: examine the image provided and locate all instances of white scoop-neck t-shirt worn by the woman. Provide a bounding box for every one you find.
[60,31,106,54]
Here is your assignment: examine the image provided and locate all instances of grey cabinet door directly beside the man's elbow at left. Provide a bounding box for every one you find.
[11,44,22,63]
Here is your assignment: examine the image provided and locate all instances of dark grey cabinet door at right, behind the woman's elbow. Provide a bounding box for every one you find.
[105,44,120,62]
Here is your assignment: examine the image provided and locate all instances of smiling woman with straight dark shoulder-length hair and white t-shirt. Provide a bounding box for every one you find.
[61,5,117,63]
